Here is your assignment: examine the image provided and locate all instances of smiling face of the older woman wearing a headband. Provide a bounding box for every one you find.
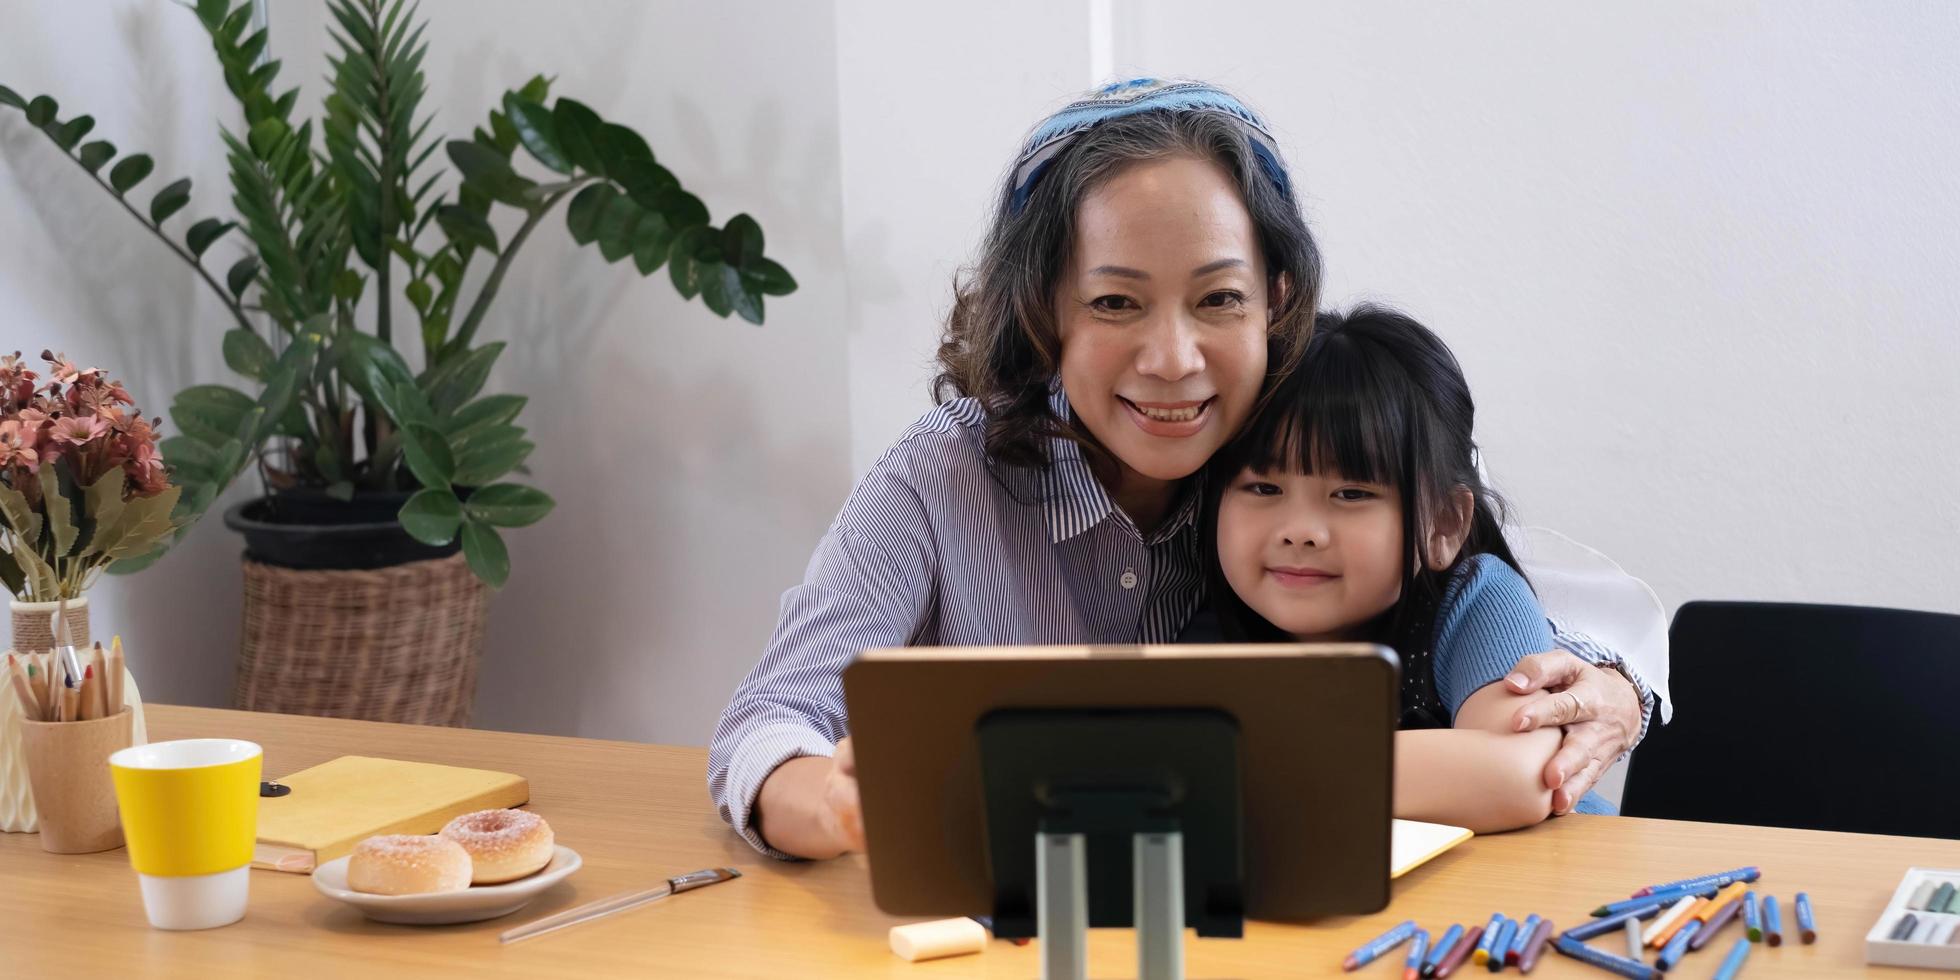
[1056,157,1268,490]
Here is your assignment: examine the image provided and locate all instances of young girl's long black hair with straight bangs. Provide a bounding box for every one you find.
[1200,306,1523,697]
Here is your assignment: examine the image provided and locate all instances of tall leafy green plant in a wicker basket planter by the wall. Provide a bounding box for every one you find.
[0,0,796,723]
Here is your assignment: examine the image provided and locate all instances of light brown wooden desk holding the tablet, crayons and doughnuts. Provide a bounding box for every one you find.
[0,706,1960,980]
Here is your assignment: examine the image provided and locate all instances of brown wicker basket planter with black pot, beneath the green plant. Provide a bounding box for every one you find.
[225,490,490,725]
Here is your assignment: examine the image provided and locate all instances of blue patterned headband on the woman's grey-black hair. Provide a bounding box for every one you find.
[1007,78,1292,214]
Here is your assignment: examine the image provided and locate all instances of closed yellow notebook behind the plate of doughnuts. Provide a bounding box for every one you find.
[251,755,531,872]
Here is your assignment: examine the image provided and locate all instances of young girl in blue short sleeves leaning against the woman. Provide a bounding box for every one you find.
[1203,306,1601,833]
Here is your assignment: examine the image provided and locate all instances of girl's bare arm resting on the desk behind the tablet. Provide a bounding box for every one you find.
[1396,684,1558,833]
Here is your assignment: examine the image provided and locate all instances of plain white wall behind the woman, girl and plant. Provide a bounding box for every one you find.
[0,0,1960,743]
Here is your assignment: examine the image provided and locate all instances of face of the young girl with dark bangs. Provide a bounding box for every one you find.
[1217,470,1407,641]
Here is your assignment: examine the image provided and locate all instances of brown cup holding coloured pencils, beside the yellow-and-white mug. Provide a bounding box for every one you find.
[20,710,135,855]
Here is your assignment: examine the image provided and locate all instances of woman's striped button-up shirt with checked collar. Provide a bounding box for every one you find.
[708,390,1652,857]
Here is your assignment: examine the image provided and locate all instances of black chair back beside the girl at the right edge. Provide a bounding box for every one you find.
[1621,602,1960,837]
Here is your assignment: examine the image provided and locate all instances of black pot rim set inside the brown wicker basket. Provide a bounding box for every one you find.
[225,488,461,568]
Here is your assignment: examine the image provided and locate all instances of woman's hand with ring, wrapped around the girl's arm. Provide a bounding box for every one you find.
[1503,651,1641,813]
